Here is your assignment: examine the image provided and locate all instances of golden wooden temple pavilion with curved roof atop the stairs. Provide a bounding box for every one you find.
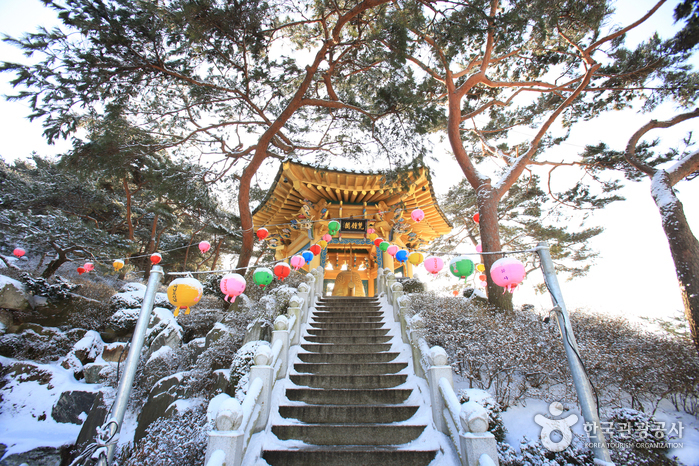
[253,160,452,296]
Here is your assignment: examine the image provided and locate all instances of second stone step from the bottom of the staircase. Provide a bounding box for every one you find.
[272,424,427,445]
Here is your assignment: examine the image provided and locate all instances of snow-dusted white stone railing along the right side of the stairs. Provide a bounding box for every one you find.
[378,270,499,466]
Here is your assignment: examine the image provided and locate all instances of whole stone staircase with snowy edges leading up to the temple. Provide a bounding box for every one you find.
[262,298,456,466]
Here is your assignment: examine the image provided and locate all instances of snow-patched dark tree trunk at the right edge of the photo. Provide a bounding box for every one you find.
[651,170,699,352]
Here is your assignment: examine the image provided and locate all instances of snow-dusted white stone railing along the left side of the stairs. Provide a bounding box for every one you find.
[205,267,323,466]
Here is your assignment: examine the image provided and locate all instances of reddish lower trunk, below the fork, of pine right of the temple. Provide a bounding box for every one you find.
[476,184,512,311]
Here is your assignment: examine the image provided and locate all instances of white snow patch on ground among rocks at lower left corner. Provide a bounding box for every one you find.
[0,356,99,455]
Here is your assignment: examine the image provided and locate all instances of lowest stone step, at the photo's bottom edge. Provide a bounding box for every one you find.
[263,445,437,466]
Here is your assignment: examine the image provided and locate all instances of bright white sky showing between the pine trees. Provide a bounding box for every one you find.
[0,0,699,326]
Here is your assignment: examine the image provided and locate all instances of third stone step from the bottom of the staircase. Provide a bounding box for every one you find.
[279,404,418,424]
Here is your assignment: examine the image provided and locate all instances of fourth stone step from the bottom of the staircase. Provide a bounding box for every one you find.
[286,388,412,405]
